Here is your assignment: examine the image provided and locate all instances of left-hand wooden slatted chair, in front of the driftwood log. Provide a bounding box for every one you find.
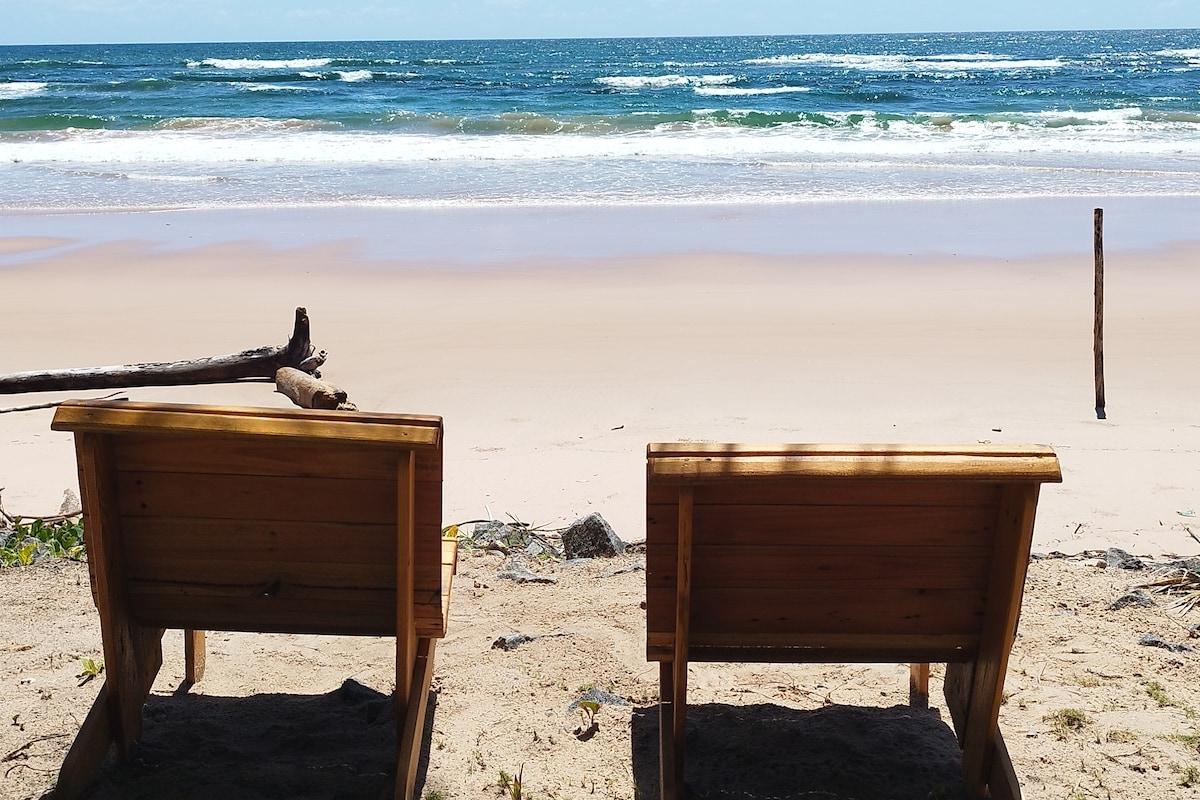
[52,402,457,800]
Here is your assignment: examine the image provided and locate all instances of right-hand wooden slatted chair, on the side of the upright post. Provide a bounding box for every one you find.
[646,444,1062,799]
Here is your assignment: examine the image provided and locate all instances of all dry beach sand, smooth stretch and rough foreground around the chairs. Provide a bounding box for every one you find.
[0,208,1200,798]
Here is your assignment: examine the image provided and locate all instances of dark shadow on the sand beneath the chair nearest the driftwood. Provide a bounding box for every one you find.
[75,680,437,800]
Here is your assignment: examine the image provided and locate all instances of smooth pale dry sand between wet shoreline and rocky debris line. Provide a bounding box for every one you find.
[0,205,1200,554]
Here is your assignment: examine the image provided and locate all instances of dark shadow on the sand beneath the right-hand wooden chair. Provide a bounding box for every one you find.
[631,703,966,800]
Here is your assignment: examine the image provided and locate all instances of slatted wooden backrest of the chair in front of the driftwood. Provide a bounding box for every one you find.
[54,403,445,637]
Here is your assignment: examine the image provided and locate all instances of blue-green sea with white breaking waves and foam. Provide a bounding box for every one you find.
[0,30,1200,211]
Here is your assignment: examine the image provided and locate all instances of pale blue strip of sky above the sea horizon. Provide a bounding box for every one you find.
[0,0,1200,44]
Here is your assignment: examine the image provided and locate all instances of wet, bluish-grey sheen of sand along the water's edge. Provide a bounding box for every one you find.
[7,196,1200,270]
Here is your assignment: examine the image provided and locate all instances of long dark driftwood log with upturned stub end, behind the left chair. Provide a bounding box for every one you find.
[0,308,326,395]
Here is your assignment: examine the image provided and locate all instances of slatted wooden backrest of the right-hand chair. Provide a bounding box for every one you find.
[647,444,1061,661]
